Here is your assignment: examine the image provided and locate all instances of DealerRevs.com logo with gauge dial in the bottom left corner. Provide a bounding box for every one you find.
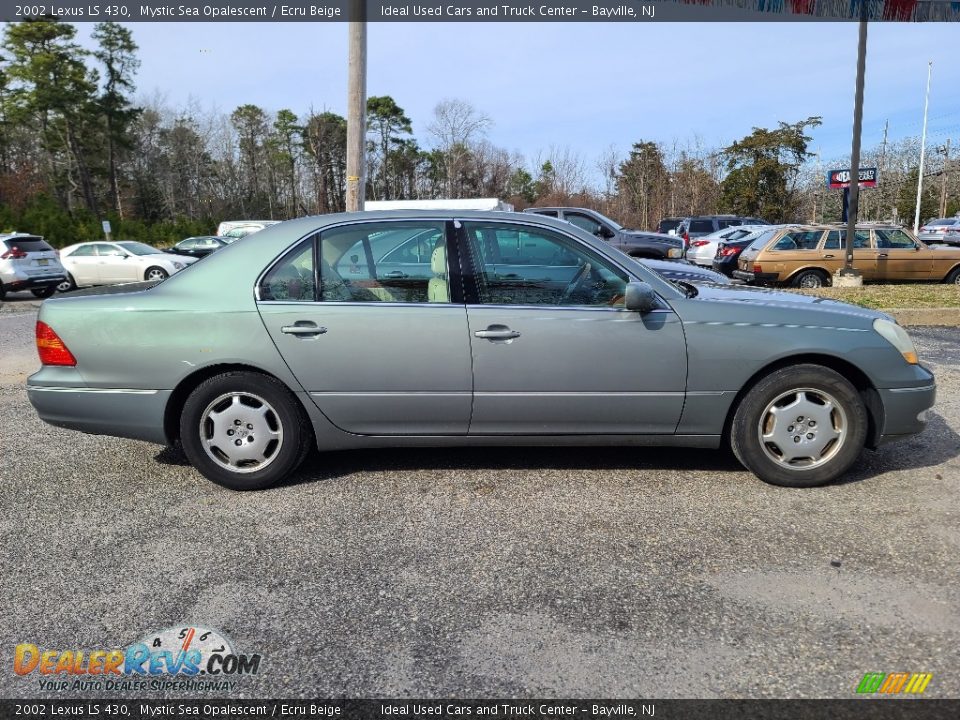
[13,626,262,691]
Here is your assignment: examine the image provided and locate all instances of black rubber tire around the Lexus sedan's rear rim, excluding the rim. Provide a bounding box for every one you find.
[180,372,311,490]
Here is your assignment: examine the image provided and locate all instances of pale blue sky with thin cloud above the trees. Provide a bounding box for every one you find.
[80,22,960,183]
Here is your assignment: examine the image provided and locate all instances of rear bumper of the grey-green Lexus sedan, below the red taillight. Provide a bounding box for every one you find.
[27,368,171,445]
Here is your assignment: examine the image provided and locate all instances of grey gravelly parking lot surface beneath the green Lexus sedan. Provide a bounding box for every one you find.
[0,298,960,698]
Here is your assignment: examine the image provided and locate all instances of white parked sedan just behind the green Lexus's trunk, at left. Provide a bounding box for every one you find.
[57,240,197,292]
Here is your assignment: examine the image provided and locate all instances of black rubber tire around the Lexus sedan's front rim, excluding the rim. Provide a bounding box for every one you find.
[730,365,868,488]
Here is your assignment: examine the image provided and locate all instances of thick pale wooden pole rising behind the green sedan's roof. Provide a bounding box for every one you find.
[346,0,367,212]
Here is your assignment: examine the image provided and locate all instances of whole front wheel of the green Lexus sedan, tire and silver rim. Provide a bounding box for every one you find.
[730,365,868,488]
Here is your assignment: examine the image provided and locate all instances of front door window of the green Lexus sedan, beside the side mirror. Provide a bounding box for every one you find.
[463,222,627,307]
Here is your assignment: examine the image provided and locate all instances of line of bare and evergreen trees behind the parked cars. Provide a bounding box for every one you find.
[0,19,960,246]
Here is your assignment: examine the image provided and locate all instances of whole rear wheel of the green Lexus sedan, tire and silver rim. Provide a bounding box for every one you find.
[180,371,313,490]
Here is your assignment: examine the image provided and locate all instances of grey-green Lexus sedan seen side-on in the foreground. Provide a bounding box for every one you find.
[28,211,936,490]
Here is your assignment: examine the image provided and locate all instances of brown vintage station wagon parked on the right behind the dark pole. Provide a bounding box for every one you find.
[733,225,960,288]
